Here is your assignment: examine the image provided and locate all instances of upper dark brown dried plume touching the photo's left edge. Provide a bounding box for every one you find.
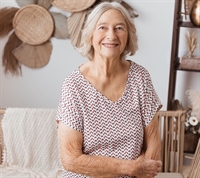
[0,7,19,37]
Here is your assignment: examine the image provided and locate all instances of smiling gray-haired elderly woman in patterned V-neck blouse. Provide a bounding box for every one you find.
[57,2,162,178]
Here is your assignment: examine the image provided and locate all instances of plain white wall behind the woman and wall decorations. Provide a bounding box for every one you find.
[0,0,200,109]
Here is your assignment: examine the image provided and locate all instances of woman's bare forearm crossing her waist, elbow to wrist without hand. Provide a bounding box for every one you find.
[62,154,137,177]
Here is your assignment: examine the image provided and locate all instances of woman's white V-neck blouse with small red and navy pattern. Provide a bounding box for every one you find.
[57,62,161,178]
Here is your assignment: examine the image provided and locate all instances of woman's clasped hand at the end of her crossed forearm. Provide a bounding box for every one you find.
[135,154,162,178]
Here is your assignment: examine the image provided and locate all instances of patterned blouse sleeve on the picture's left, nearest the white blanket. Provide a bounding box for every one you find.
[56,78,83,132]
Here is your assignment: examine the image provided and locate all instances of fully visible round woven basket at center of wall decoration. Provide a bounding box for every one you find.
[13,4,54,45]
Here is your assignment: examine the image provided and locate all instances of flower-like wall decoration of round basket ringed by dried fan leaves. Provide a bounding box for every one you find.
[0,0,69,75]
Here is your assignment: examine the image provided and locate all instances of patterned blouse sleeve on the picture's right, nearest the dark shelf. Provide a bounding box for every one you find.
[141,70,162,127]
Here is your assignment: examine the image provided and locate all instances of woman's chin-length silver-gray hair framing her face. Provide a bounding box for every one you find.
[77,2,138,59]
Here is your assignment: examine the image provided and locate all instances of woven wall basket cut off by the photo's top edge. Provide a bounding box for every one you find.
[52,0,96,12]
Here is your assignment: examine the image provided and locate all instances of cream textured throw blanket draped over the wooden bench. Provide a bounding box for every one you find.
[0,108,61,178]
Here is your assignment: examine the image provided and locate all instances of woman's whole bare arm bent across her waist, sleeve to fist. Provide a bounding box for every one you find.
[58,122,161,178]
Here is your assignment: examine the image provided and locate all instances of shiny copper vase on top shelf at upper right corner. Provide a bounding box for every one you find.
[190,0,200,26]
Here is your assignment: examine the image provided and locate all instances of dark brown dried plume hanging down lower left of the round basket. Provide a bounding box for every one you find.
[3,32,23,75]
